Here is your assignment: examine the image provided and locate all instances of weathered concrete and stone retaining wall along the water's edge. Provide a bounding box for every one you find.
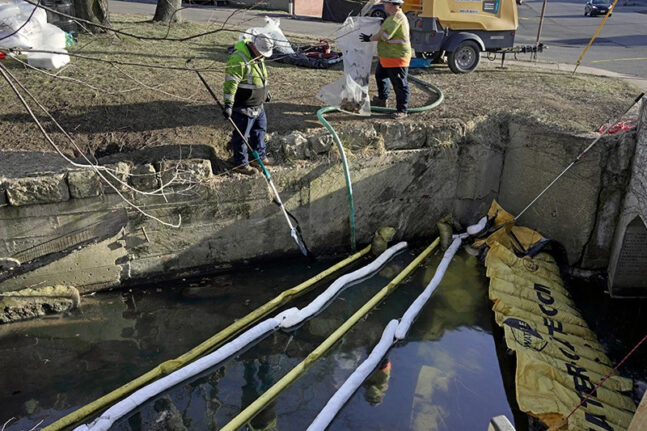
[0,111,636,292]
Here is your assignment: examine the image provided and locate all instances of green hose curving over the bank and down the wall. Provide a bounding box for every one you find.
[317,76,445,251]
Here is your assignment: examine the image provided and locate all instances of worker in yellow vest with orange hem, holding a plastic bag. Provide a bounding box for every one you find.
[360,0,411,119]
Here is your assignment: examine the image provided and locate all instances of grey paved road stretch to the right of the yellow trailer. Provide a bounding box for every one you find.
[515,0,647,78]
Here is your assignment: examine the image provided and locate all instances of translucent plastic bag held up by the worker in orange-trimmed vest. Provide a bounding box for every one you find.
[317,16,382,116]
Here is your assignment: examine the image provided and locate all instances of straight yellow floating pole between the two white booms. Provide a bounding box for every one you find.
[220,238,440,431]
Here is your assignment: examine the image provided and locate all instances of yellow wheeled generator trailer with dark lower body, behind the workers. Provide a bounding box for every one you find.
[362,0,527,73]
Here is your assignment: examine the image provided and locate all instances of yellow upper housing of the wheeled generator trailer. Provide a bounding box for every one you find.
[418,0,519,31]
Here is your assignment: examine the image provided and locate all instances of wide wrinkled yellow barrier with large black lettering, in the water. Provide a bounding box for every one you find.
[474,201,636,431]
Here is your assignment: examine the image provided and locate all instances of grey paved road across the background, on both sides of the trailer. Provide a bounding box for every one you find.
[110,0,647,78]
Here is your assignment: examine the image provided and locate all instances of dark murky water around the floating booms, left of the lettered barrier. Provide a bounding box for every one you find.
[0,251,532,431]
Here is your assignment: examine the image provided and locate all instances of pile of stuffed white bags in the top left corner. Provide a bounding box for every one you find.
[0,0,70,69]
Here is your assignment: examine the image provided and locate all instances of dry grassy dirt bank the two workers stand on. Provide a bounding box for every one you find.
[0,16,638,160]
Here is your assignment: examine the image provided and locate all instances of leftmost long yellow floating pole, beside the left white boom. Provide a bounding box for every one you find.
[42,245,371,431]
